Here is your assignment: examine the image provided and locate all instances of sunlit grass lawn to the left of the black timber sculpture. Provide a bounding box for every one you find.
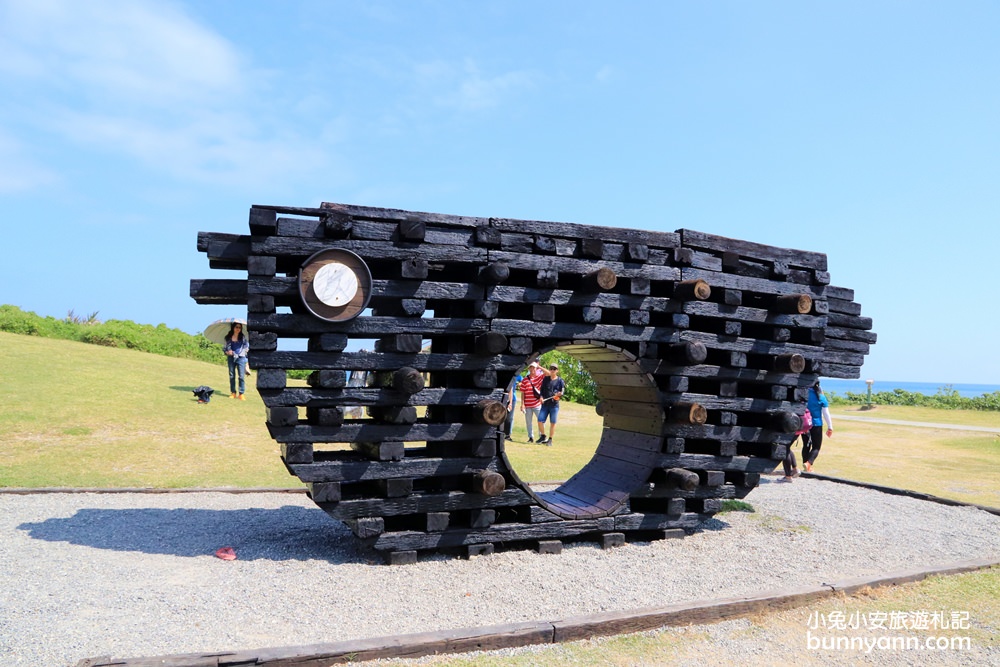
[0,333,290,488]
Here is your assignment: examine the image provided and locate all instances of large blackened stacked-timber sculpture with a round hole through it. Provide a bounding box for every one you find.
[191,203,875,563]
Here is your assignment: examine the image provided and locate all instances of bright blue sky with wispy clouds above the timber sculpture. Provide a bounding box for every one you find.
[0,0,1000,384]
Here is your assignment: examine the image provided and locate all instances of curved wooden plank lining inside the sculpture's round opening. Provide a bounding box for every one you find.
[504,341,664,519]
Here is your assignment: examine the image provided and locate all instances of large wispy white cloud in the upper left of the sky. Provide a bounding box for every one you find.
[0,0,336,188]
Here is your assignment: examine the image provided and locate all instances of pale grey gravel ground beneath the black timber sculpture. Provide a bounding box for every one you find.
[0,478,1000,667]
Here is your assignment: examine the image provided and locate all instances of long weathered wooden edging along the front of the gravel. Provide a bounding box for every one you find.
[75,558,1000,667]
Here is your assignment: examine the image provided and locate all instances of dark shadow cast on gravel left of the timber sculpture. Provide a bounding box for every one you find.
[18,505,381,563]
